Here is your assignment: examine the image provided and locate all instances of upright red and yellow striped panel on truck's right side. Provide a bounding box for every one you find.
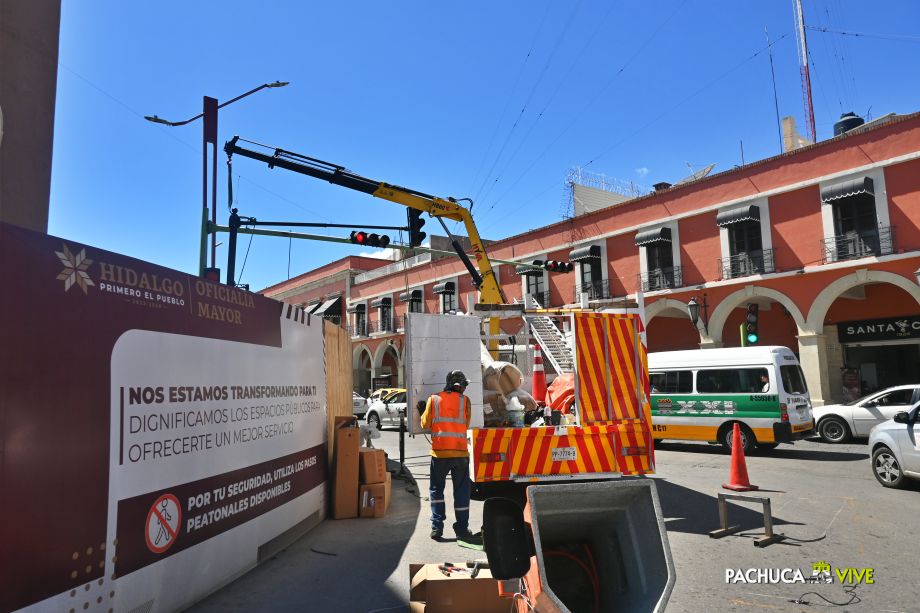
[574,313,651,424]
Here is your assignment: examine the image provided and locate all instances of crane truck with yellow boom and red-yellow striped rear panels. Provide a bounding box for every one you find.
[224,136,655,489]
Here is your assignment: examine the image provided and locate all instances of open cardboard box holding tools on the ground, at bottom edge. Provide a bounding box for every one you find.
[409,562,510,613]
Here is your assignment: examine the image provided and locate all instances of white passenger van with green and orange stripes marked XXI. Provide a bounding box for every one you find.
[648,346,815,451]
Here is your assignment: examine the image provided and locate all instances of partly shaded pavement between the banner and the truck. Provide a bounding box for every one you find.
[189,432,485,613]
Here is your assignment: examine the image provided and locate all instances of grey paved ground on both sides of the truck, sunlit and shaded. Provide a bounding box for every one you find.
[193,431,920,613]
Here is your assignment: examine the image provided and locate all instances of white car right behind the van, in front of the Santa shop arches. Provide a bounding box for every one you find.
[812,385,920,443]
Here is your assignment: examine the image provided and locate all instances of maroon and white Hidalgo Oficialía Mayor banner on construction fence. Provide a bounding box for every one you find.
[0,224,326,612]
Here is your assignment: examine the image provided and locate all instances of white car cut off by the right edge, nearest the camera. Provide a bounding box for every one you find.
[869,403,920,487]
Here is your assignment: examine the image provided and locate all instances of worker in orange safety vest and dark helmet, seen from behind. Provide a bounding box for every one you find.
[422,370,472,541]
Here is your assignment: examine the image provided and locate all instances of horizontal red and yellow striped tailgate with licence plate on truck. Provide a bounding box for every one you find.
[472,420,654,483]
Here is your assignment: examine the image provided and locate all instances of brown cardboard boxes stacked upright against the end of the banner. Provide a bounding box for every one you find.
[332,417,392,519]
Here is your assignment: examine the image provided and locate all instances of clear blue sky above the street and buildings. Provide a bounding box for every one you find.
[49,0,920,289]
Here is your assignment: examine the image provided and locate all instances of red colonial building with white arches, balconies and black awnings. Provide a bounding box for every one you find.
[263,113,920,404]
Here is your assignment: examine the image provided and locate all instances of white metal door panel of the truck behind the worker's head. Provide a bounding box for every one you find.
[405,313,483,434]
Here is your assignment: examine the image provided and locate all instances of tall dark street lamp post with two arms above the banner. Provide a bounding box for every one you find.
[144,81,288,281]
